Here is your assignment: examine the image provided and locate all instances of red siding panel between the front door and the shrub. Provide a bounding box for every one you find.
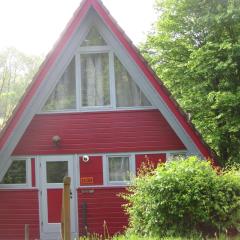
[78,188,128,235]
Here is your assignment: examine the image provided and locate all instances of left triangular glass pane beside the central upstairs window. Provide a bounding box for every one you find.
[43,59,76,111]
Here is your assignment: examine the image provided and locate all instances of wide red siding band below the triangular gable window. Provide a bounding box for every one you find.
[14,110,185,155]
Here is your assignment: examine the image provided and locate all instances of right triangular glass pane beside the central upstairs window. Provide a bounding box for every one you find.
[114,56,151,107]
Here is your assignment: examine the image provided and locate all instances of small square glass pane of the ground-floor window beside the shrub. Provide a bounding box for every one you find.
[108,157,130,182]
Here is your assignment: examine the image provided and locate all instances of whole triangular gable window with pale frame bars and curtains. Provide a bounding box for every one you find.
[43,27,151,112]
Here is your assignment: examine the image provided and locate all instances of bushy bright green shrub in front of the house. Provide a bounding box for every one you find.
[123,157,240,236]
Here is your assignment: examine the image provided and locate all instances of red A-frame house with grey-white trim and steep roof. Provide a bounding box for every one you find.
[0,0,214,240]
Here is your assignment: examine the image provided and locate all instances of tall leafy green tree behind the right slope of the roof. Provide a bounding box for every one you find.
[142,0,240,165]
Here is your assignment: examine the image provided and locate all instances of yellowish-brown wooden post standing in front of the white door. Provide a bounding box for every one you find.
[61,177,71,240]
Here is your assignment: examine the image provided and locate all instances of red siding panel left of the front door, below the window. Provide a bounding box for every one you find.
[0,189,40,240]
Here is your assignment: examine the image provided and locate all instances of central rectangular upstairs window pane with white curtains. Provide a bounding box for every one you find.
[81,53,110,106]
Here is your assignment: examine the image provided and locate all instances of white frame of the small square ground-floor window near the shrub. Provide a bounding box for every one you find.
[103,154,136,186]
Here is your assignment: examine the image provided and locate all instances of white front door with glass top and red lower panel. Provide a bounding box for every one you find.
[39,155,77,240]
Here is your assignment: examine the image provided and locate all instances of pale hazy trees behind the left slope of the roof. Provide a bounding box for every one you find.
[0,48,41,130]
